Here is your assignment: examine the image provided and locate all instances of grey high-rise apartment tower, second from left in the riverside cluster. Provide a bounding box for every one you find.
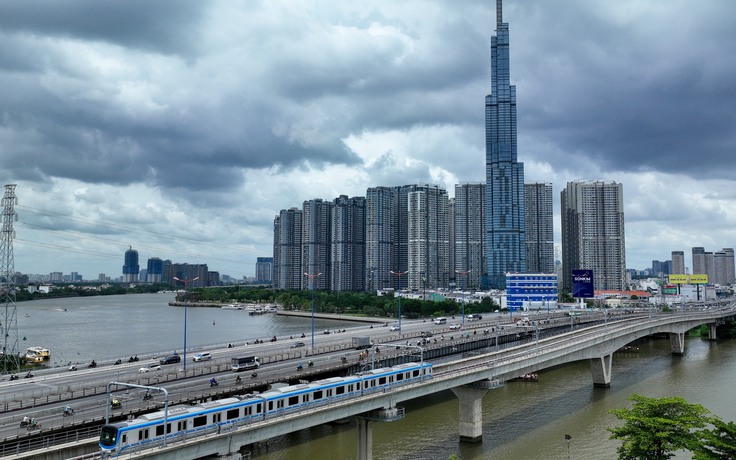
[302,198,333,290]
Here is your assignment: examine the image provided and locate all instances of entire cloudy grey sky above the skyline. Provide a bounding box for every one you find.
[0,0,736,279]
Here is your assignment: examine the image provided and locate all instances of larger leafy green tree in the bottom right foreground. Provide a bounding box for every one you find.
[607,394,711,460]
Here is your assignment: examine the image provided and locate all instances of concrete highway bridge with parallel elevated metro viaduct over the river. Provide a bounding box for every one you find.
[0,305,736,460]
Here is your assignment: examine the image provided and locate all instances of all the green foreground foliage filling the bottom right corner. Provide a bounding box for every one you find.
[607,394,736,460]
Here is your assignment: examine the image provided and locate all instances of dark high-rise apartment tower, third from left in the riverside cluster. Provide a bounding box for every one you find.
[330,195,366,291]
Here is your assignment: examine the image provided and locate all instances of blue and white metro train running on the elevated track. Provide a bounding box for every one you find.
[99,363,432,456]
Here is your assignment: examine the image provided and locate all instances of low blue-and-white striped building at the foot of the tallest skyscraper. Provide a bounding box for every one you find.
[506,273,558,311]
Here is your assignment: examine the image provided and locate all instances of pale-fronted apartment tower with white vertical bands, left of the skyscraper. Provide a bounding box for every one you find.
[406,185,450,290]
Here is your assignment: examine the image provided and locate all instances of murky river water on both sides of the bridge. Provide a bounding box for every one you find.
[11,294,736,460]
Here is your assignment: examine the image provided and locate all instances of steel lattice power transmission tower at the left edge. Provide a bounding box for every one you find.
[0,184,20,374]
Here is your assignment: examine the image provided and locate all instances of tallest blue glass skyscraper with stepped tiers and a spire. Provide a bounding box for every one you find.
[486,0,526,289]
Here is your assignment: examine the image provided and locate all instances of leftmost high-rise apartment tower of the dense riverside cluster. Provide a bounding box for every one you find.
[273,208,304,289]
